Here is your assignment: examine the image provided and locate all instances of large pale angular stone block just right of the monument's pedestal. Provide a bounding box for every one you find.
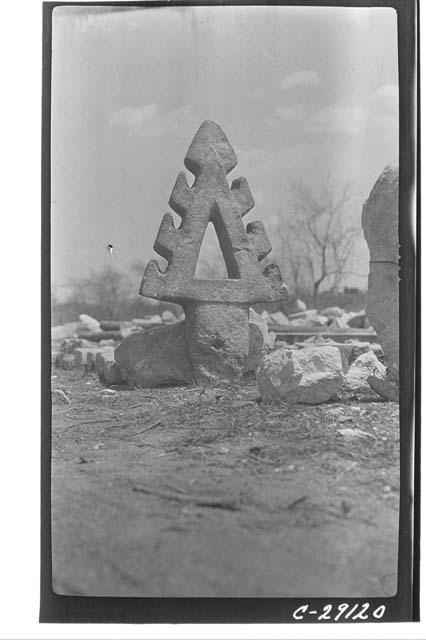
[257,346,343,404]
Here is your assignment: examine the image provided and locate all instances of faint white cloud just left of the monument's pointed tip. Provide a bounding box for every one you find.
[109,103,194,138]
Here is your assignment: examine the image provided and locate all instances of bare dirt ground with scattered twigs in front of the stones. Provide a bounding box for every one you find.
[52,370,399,597]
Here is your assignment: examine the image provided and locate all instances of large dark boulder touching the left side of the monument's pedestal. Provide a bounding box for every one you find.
[115,322,193,387]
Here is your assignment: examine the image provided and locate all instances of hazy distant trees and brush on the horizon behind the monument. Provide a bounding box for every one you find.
[52,177,365,325]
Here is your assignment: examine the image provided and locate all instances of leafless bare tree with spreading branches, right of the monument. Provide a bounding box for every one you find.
[274,177,359,305]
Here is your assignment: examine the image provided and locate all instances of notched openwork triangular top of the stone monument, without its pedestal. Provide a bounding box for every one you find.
[140,120,287,306]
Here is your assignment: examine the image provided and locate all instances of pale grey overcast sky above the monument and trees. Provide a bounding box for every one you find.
[52,6,398,294]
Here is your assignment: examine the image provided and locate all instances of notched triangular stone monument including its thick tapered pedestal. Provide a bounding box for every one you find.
[140,120,287,384]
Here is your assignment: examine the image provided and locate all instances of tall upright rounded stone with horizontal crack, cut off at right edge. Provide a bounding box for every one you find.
[362,165,399,381]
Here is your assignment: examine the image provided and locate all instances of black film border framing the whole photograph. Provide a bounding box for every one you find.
[39,0,420,624]
